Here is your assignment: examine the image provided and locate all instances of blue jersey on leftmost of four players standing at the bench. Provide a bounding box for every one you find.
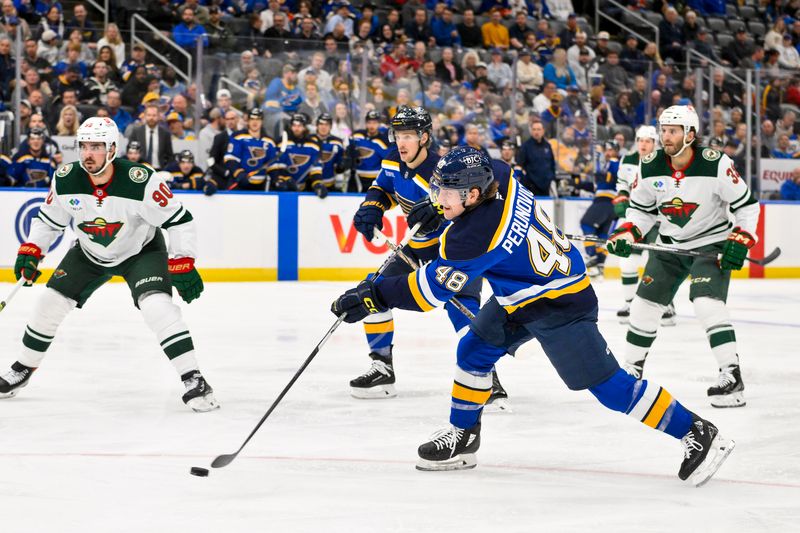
[224,129,278,188]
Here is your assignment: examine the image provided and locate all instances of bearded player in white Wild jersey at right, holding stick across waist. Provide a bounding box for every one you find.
[607,106,759,407]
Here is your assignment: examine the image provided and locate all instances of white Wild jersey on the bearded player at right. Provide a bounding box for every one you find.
[626,147,759,249]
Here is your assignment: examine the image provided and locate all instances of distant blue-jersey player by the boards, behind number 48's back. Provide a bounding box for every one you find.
[581,141,619,275]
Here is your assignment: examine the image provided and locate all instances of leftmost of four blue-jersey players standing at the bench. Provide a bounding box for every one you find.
[224,107,278,191]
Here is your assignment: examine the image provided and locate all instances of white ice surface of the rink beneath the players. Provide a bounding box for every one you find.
[0,280,800,533]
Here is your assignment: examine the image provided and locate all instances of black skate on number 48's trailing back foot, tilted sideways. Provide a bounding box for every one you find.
[678,416,736,487]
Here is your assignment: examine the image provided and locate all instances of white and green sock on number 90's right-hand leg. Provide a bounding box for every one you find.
[139,292,198,376]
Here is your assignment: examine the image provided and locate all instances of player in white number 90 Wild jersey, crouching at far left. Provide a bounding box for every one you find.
[0,117,219,412]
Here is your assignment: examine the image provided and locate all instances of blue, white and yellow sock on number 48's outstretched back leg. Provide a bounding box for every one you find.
[589,369,692,439]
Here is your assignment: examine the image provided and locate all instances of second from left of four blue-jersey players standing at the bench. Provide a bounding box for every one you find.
[270,113,326,198]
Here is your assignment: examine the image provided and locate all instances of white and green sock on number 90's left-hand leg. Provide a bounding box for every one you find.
[19,288,76,368]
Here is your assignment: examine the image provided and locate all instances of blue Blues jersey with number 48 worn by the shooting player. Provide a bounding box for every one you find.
[376,166,589,323]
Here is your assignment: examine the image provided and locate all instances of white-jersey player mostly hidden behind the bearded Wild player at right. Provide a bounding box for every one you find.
[613,126,675,326]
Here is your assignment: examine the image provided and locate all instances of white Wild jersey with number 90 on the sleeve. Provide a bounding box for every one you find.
[28,159,197,266]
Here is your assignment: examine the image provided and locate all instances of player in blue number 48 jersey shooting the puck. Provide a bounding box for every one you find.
[331,143,734,485]
